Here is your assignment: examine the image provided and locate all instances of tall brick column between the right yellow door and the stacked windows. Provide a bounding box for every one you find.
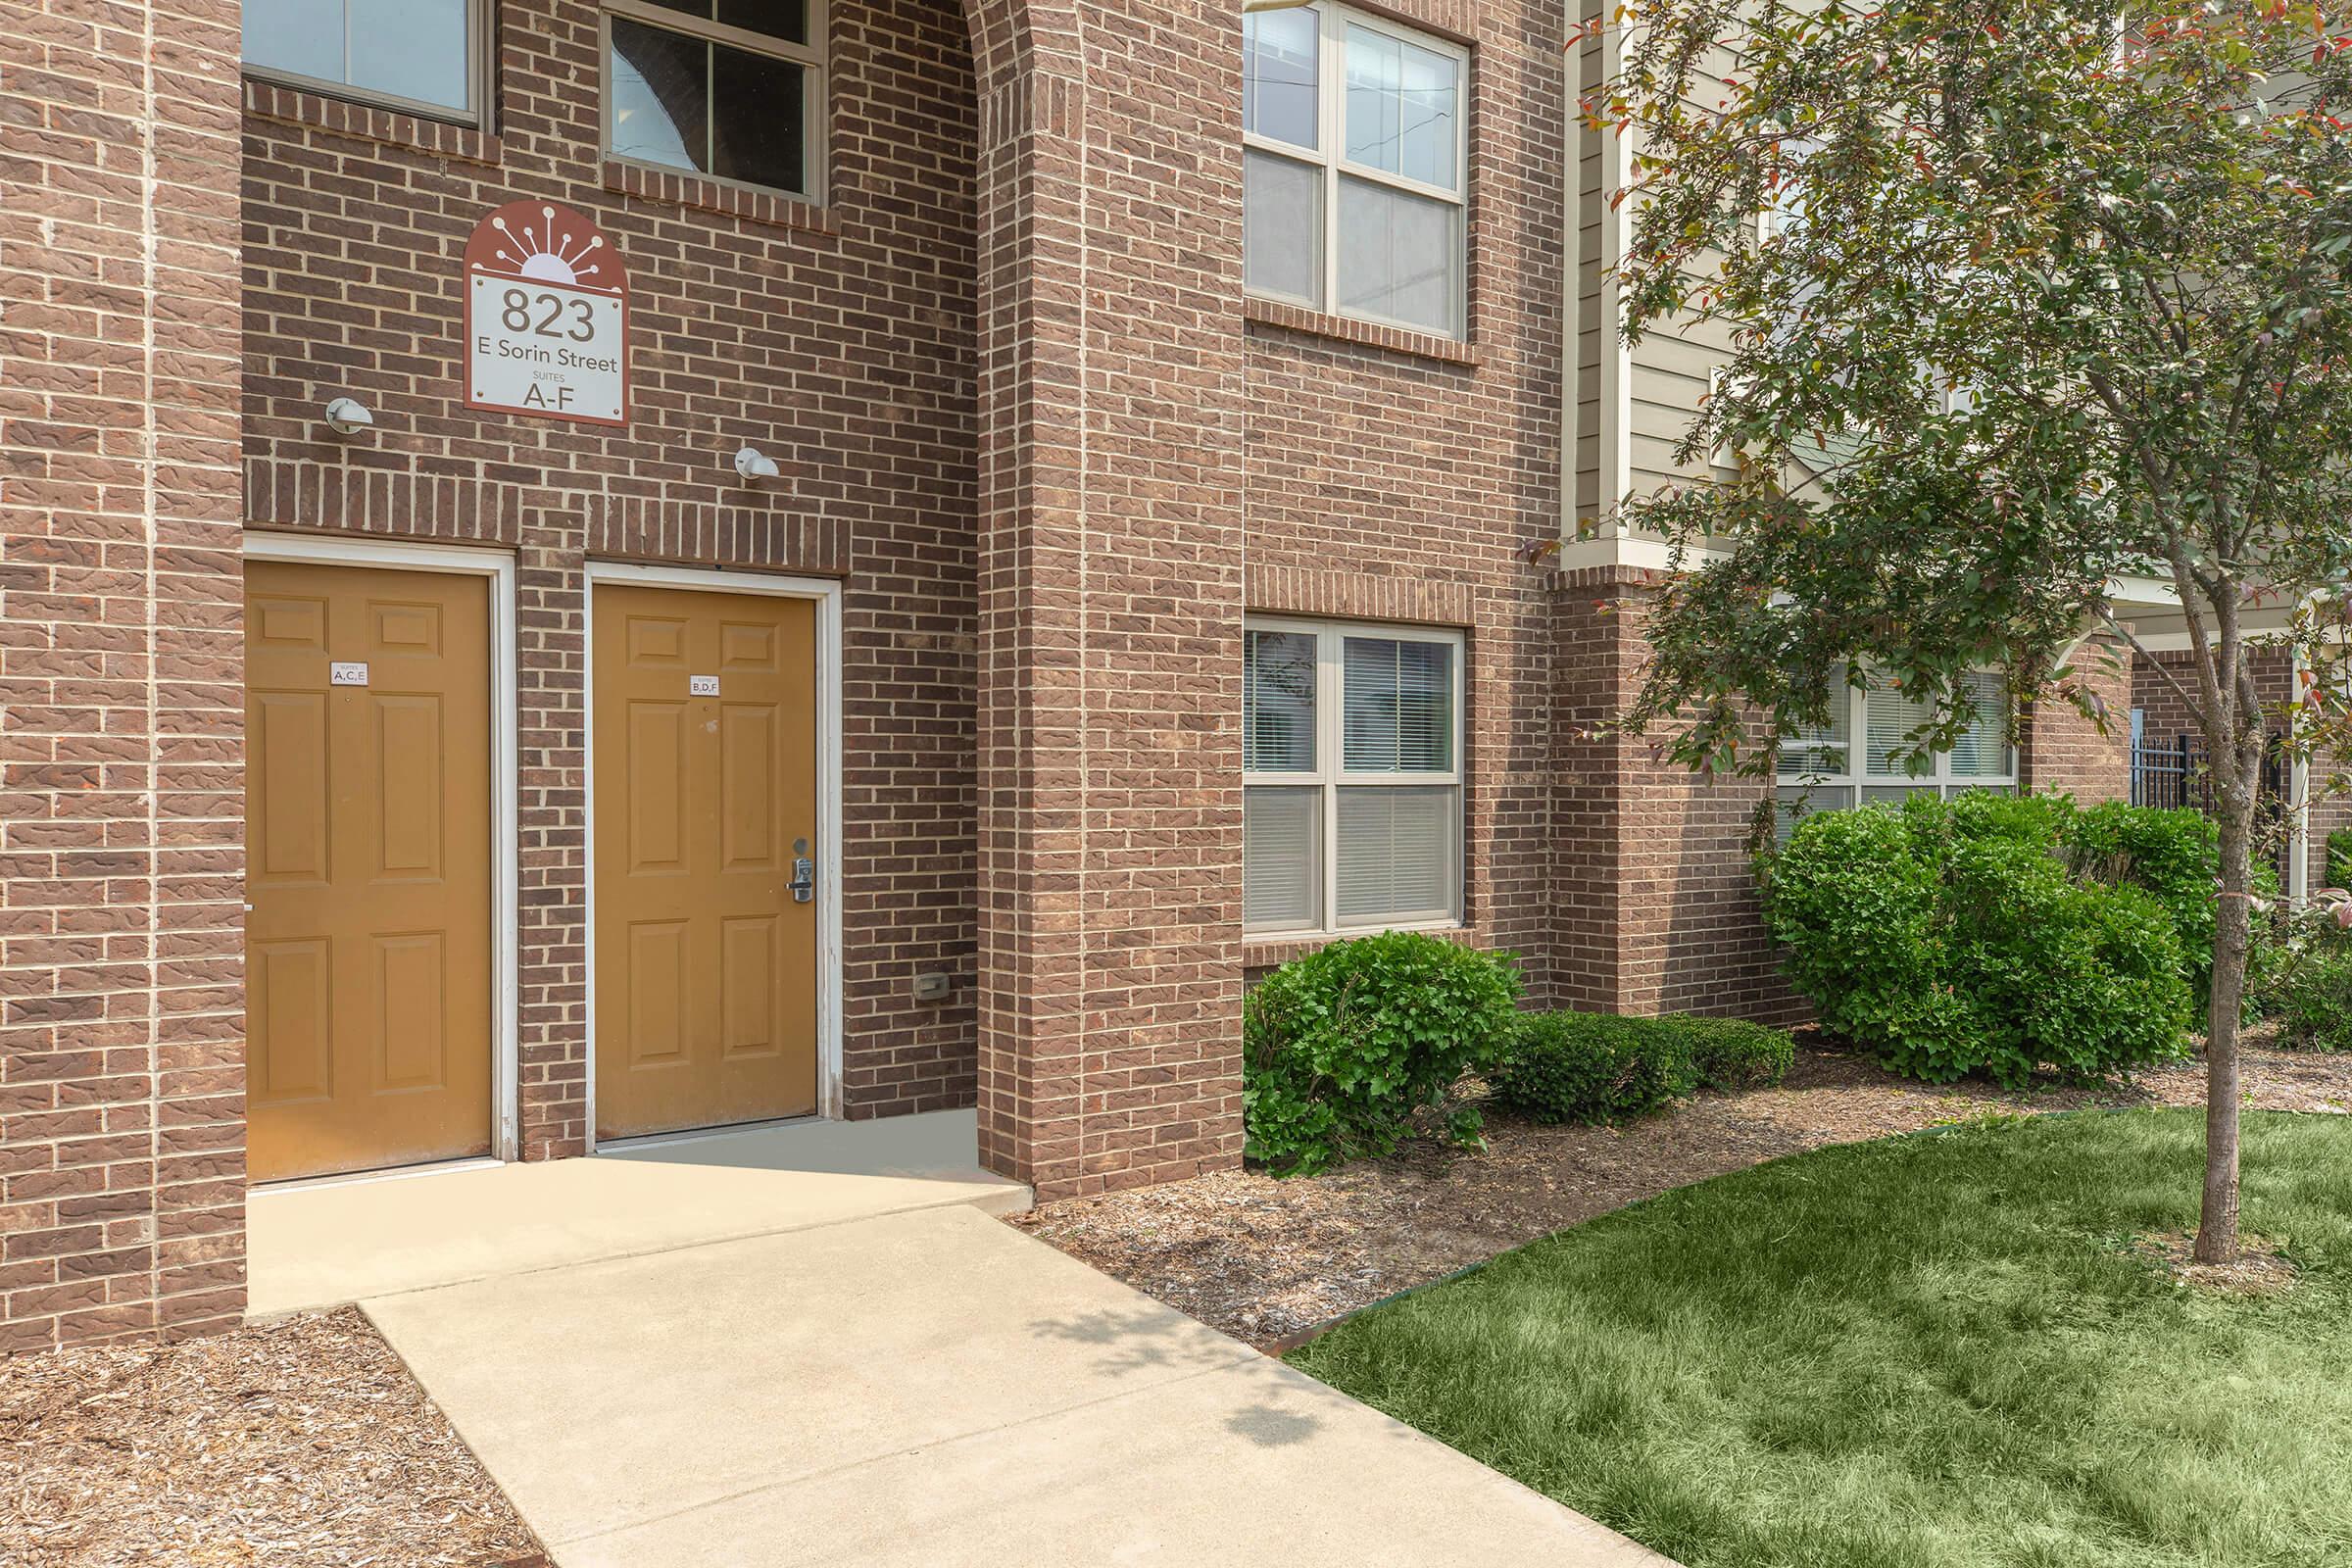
[971,0,1242,1197]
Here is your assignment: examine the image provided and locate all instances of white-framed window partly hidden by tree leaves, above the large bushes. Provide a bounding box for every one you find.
[1776,670,2018,842]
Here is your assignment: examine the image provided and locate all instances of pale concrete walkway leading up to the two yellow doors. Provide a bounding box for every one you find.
[257,1114,1670,1568]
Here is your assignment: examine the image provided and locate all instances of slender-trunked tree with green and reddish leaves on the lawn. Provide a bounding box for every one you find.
[1586,0,2352,1262]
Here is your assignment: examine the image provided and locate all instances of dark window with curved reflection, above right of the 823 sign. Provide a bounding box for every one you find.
[605,0,825,200]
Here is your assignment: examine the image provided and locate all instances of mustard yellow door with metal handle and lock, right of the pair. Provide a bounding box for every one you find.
[590,585,816,1138]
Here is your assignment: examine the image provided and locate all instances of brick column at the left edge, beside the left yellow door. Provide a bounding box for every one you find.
[0,0,245,1349]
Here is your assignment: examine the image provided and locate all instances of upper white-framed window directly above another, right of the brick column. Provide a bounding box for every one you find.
[1242,0,1470,338]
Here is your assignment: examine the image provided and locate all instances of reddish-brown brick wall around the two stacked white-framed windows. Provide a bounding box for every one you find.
[1245,0,1564,995]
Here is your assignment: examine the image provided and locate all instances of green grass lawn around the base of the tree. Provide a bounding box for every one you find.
[1292,1112,2352,1568]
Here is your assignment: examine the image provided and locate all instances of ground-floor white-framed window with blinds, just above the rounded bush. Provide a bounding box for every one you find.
[1242,615,1463,936]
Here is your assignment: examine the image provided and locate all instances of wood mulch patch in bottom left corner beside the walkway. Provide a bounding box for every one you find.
[0,1307,548,1568]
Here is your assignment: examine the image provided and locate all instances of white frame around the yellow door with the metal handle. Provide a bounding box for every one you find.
[581,562,842,1154]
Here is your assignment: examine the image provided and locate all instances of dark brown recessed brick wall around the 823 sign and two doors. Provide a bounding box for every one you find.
[245,0,976,1159]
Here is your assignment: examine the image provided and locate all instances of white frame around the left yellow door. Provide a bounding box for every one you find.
[245,529,522,1185]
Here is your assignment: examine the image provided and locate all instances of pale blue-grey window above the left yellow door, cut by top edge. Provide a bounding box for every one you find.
[245,0,484,122]
